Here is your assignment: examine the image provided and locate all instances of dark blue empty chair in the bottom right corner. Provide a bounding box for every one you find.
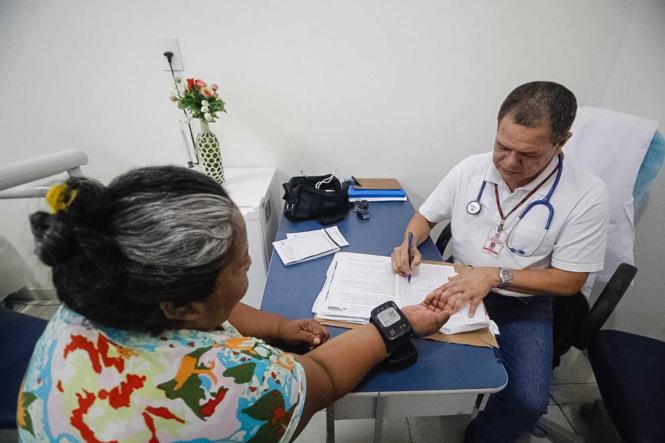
[589,330,665,443]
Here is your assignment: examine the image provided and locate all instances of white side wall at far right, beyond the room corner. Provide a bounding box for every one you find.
[599,1,665,339]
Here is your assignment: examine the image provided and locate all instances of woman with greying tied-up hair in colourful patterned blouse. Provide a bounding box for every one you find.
[17,167,449,442]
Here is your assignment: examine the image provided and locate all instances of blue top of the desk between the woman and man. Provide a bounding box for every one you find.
[261,202,508,393]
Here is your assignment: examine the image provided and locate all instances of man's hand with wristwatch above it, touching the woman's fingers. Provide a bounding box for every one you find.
[425,266,499,317]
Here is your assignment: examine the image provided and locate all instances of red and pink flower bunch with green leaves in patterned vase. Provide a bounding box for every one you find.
[170,77,226,122]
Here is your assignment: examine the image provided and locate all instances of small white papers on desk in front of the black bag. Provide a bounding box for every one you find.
[273,226,349,266]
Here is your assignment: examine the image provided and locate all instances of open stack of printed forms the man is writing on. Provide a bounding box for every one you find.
[312,252,499,334]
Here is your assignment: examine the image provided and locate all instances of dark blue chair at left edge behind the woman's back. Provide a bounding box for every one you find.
[0,307,48,429]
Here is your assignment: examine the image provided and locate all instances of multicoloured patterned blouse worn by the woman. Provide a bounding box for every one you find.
[17,307,306,442]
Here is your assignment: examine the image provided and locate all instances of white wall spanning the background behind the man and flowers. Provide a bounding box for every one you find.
[0,0,665,335]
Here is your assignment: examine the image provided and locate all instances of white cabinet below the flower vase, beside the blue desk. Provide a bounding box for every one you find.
[223,168,281,309]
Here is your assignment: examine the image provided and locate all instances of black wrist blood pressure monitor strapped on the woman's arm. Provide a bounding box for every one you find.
[369,301,418,372]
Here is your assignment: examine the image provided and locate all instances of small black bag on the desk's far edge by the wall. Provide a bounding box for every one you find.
[282,175,351,225]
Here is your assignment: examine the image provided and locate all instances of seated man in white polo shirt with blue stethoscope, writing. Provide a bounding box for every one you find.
[392,82,608,442]
